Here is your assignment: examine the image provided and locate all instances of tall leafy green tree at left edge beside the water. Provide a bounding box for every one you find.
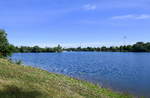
[0,30,14,57]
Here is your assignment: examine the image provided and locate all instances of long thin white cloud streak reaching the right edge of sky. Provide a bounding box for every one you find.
[112,14,150,20]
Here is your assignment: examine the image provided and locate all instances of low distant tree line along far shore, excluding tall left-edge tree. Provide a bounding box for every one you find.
[13,42,150,53]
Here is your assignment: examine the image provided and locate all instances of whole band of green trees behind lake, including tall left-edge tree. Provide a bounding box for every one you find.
[0,30,150,57]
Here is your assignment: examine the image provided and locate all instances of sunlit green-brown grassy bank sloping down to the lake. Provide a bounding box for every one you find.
[0,59,132,98]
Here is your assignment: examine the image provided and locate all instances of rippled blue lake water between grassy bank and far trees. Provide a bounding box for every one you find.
[12,52,150,98]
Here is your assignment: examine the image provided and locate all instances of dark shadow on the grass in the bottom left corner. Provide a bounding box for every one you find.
[0,85,42,98]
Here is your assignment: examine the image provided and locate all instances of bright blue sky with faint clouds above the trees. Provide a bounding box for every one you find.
[0,0,150,47]
